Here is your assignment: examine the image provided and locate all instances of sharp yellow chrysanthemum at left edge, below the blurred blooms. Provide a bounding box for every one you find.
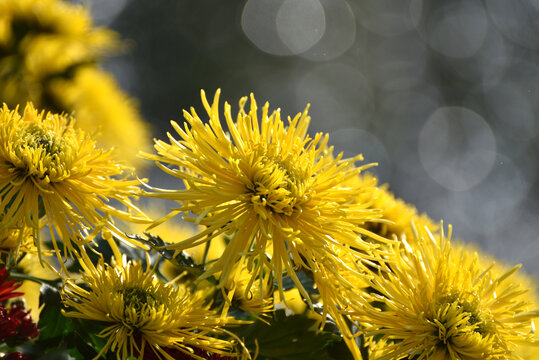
[0,104,146,264]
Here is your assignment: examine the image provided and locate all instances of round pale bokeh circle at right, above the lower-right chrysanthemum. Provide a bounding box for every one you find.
[418,107,496,191]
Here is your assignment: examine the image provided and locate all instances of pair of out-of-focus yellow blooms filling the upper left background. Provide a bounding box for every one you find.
[0,0,151,165]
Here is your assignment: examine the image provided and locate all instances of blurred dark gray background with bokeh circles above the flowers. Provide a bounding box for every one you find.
[81,0,539,275]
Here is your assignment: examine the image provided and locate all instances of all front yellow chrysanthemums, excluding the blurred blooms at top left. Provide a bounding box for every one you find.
[0,86,539,360]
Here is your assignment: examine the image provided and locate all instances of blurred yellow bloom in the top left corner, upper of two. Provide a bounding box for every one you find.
[0,0,119,107]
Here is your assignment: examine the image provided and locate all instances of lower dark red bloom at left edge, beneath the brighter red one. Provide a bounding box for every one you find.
[0,302,39,346]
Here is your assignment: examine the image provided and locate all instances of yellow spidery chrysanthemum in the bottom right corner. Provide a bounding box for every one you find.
[356,225,539,360]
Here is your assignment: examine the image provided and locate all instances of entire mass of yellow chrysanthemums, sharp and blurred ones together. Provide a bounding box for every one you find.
[0,4,539,360]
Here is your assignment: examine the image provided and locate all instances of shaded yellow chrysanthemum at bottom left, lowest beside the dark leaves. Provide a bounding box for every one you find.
[62,252,246,360]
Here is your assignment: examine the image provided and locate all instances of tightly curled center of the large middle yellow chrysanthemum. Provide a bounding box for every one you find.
[247,156,304,216]
